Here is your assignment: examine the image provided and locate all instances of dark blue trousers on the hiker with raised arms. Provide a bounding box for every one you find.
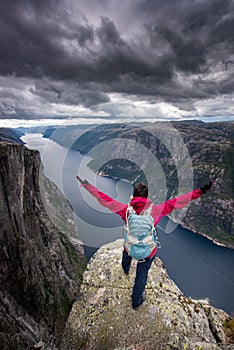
[122,250,156,309]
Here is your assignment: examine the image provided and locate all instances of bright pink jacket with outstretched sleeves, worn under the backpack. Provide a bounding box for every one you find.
[81,184,203,226]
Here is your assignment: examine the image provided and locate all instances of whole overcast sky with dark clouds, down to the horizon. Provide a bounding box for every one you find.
[0,0,234,126]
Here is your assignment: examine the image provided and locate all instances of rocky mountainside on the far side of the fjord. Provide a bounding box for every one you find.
[49,122,234,247]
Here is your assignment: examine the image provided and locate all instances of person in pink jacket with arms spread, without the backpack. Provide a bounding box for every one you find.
[77,176,214,310]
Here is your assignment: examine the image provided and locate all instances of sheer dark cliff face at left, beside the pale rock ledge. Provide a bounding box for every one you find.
[0,143,85,350]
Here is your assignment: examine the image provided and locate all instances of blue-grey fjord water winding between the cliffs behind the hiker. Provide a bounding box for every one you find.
[22,134,234,314]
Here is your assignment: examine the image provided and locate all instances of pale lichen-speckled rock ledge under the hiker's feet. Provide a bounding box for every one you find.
[62,240,234,350]
